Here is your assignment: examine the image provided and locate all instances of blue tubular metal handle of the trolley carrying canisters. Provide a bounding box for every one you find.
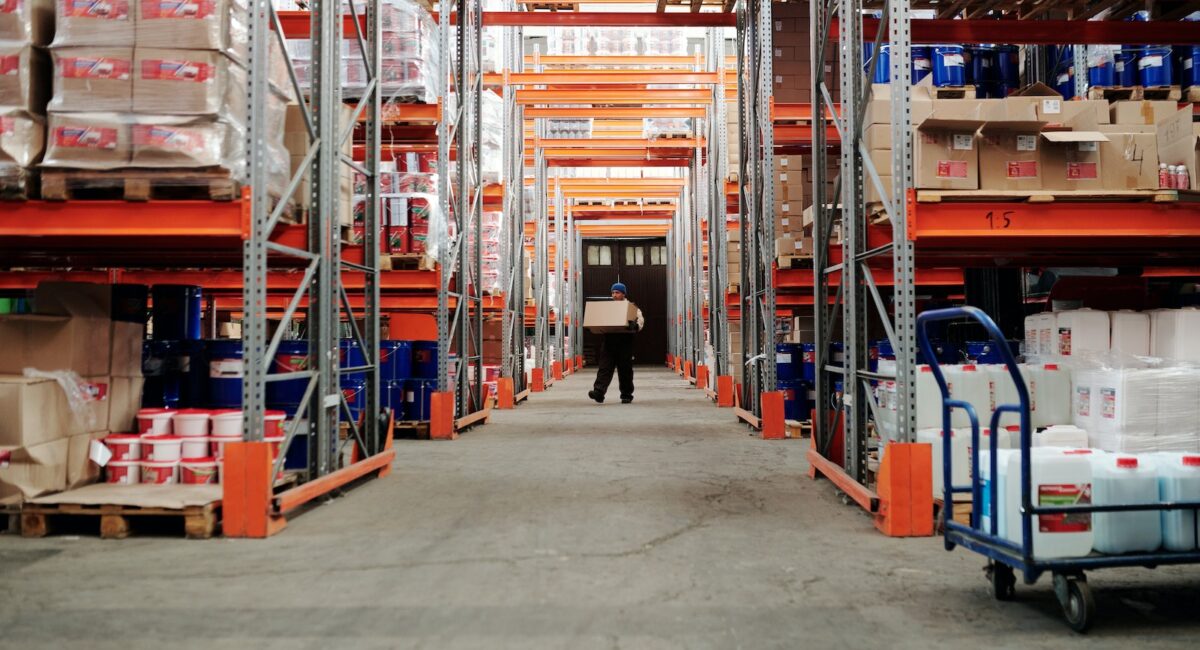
[917,307,1032,548]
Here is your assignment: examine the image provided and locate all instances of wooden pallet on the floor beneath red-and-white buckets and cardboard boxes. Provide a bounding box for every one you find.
[20,502,220,540]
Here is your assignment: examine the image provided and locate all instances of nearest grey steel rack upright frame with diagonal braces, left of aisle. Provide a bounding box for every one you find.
[242,0,383,489]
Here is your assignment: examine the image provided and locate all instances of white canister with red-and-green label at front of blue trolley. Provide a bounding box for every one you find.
[1001,447,1093,559]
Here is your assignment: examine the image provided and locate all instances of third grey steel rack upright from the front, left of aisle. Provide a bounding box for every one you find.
[500,2,527,395]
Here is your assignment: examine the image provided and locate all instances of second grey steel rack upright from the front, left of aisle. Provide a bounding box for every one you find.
[439,0,486,417]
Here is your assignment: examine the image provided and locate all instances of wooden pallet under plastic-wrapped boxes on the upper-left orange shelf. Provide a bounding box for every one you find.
[42,169,241,201]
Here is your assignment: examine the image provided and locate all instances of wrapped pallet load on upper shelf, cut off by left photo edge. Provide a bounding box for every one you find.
[0,0,54,199]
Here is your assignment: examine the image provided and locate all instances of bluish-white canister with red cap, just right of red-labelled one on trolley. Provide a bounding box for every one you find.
[1092,453,1163,554]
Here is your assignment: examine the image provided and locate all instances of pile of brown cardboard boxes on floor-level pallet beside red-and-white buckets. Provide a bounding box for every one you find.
[0,283,143,499]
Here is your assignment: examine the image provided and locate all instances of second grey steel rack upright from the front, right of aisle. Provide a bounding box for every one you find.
[737,0,775,417]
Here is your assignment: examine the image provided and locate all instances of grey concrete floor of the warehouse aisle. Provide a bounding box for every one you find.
[0,367,1200,649]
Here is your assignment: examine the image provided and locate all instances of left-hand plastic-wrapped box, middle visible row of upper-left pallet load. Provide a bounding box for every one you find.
[49,47,133,112]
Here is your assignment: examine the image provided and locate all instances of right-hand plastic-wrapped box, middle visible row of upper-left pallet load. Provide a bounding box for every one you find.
[133,47,247,116]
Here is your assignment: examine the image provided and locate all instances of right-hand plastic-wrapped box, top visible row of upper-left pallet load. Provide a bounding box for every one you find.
[137,0,250,62]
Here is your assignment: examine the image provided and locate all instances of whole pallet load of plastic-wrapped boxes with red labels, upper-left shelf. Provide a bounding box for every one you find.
[42,0,289,200]
